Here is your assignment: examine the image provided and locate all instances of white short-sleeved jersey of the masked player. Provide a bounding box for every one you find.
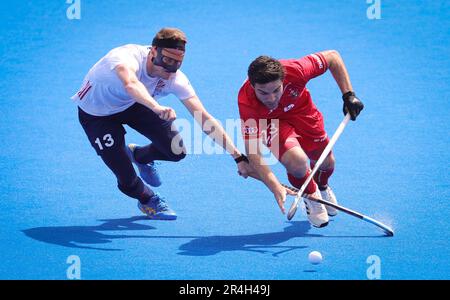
[71,44,195,116]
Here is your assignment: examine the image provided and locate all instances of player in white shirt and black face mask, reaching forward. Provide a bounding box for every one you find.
[72,28,250,220]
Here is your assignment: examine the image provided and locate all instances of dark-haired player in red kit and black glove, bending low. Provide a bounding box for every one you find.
[238,50,364,227]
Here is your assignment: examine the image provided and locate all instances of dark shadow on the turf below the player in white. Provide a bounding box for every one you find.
[22,216,156,251]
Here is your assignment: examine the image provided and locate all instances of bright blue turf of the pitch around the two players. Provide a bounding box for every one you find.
[0,0,450,279]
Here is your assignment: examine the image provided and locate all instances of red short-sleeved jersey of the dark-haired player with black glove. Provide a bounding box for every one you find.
[238,53,328,139]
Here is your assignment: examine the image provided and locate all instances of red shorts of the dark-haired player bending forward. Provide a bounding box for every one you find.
[266,116,329,161]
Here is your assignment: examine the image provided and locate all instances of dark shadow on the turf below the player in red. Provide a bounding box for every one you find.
[178,221,322,256]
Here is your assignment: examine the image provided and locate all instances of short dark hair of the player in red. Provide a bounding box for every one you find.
[247,55,284,86]
